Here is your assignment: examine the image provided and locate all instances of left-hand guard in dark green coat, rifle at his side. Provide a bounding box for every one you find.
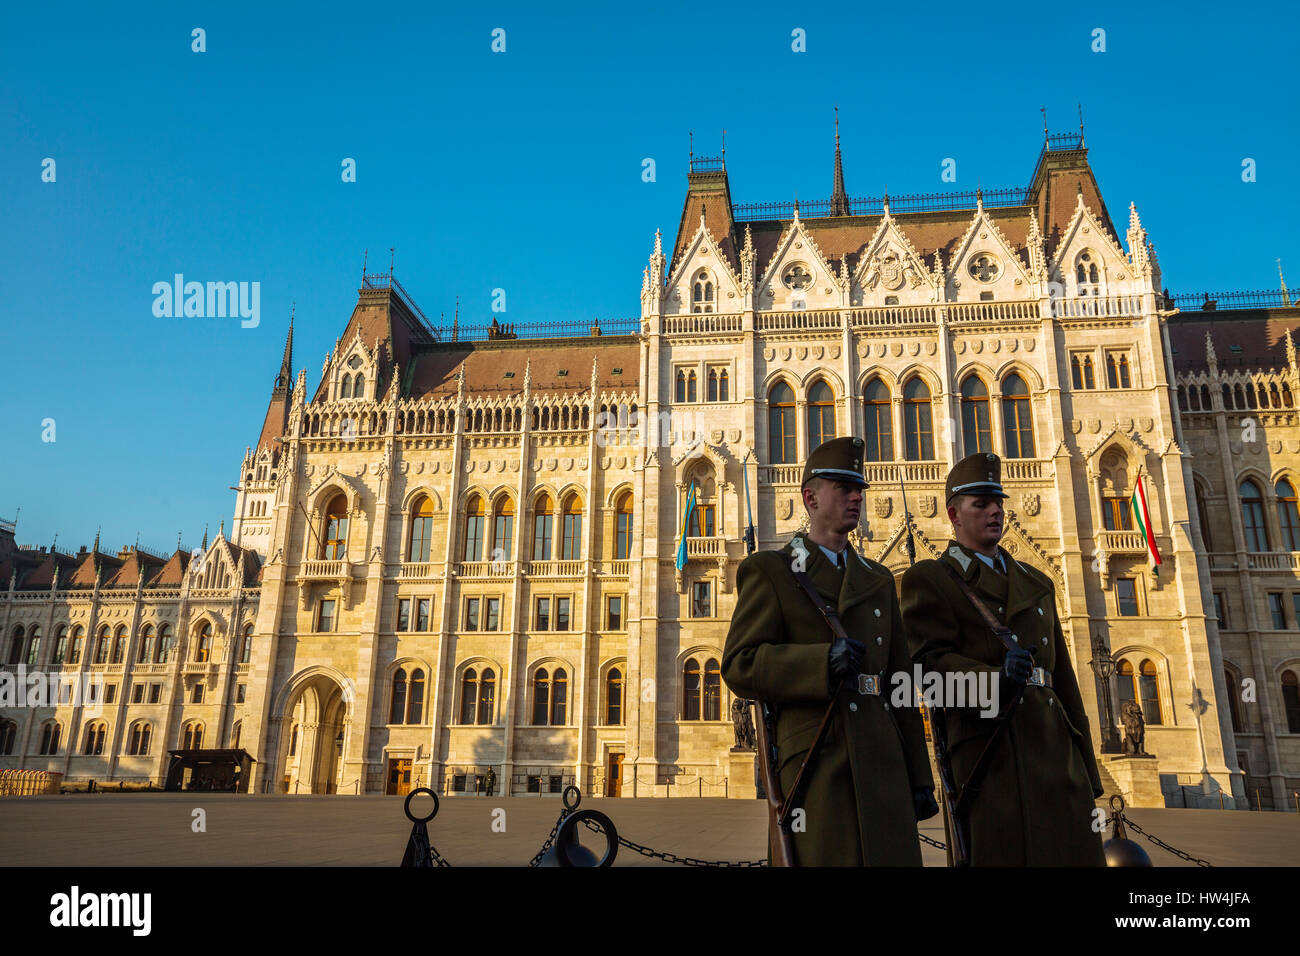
[722,438,939,866]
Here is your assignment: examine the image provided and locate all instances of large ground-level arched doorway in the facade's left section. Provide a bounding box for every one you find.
[277,671,352,793]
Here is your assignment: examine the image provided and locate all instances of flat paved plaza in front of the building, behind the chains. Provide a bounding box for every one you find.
[0,793,1300,866]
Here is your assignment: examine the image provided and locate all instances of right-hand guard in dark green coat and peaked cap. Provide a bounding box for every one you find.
[902,453,1105,866]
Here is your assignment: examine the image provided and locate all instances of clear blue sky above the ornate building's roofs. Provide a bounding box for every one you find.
[0,3,1300,550]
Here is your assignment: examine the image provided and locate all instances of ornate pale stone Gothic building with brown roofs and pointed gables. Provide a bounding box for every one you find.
[0,135,1300,808]
